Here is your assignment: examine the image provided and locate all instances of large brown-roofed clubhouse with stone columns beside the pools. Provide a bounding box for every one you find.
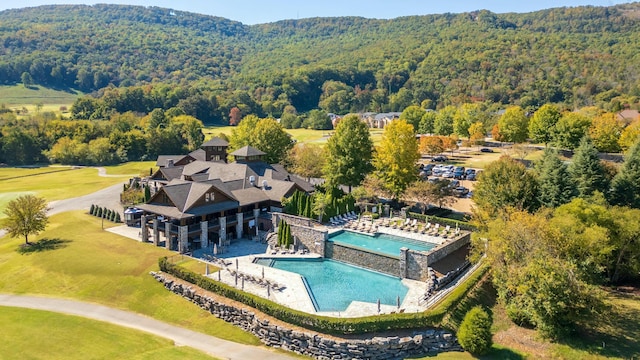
[138,139,314,252]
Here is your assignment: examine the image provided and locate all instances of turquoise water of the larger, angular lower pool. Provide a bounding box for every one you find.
[266,259,408,311]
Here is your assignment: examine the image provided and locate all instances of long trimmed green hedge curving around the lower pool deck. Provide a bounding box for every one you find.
[159,257,488,335]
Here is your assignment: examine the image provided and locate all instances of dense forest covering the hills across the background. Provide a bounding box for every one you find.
[0,3,640,123]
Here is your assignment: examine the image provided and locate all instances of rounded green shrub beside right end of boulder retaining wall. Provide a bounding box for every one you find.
[458,306,491,355]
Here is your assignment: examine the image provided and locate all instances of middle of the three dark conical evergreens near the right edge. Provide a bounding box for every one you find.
[569,136,609,198]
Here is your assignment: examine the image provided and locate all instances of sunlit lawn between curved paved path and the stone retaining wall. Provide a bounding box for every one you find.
[0,211,259,345]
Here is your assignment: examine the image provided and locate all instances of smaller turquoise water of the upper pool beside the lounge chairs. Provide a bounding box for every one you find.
[329,231,436,256]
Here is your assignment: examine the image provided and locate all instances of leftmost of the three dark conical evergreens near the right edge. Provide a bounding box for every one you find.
[537,148,576,208]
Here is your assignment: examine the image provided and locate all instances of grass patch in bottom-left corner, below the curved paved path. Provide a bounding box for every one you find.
[0,307,218,360]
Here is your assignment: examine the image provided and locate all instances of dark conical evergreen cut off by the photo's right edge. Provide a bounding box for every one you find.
[609,141,640,209]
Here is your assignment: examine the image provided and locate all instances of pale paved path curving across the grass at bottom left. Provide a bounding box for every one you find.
[0,294,293,360]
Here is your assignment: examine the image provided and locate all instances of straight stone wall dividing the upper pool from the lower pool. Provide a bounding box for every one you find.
[325,241,403,277]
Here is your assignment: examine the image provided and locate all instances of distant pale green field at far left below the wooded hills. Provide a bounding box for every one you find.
[0,84,83,107]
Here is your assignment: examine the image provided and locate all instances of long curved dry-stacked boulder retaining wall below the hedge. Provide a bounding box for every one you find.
[151,272,462,360]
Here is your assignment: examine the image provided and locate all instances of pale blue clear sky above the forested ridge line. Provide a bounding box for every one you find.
[0,0,631,25]
